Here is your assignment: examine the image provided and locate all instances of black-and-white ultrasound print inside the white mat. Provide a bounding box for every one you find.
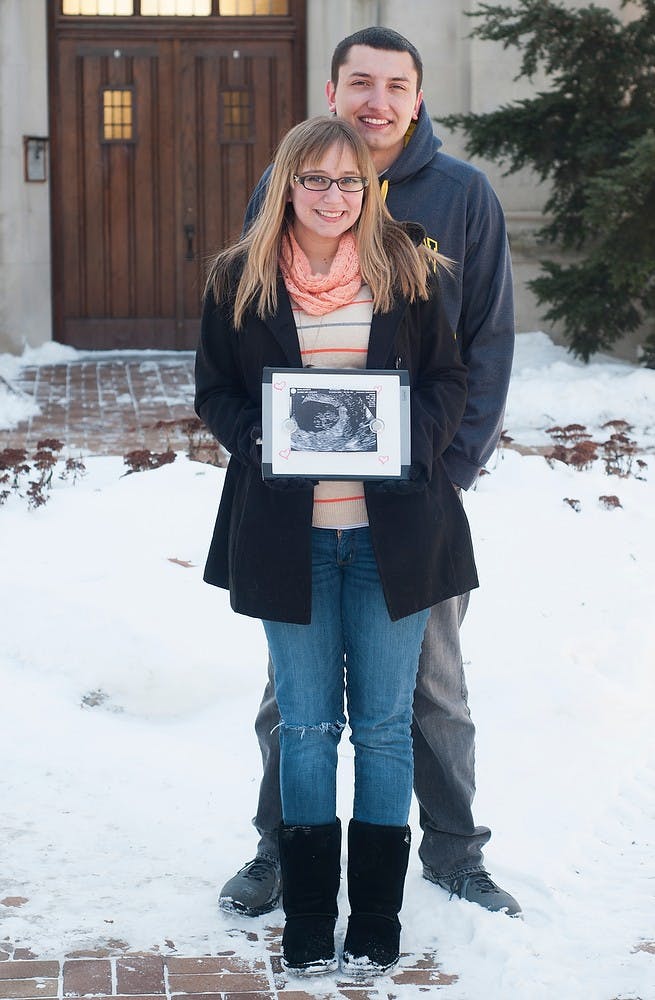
[290,389,379,452]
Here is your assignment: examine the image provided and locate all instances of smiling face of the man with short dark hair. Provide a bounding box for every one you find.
[326,45,423,173]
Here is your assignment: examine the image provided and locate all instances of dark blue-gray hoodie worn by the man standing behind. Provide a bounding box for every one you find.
[245,104,514,489]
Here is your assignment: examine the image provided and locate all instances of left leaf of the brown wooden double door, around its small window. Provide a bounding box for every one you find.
[55,39,178,348]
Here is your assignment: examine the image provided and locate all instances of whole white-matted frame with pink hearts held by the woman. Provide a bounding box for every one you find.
[262,368,411,480]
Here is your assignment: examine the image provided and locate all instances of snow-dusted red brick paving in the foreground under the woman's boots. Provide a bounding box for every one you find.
[0,926,457,1000]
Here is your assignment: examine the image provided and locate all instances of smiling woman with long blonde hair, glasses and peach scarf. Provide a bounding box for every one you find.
[196,117,477,975]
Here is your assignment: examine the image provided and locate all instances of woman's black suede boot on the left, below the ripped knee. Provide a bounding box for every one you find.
[279,820,341,976]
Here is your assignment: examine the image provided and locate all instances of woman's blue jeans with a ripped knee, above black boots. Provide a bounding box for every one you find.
[264,528,429,826]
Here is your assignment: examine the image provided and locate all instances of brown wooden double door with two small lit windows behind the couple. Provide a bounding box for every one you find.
[51,15,305,349]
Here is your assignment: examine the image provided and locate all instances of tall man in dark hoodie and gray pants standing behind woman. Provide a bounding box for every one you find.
[219,27,521,916]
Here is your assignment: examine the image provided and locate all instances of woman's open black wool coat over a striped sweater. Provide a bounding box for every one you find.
[195,275,478,624]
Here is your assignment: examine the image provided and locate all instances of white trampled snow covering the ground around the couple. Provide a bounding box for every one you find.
[0,334,655,1000]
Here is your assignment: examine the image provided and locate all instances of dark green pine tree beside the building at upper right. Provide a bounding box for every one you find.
[441,0,655,368]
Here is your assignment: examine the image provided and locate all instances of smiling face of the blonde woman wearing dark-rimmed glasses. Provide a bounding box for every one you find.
[290,146,364,251]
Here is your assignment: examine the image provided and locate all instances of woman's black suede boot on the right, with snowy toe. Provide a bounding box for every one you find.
[342,819,411,977]
